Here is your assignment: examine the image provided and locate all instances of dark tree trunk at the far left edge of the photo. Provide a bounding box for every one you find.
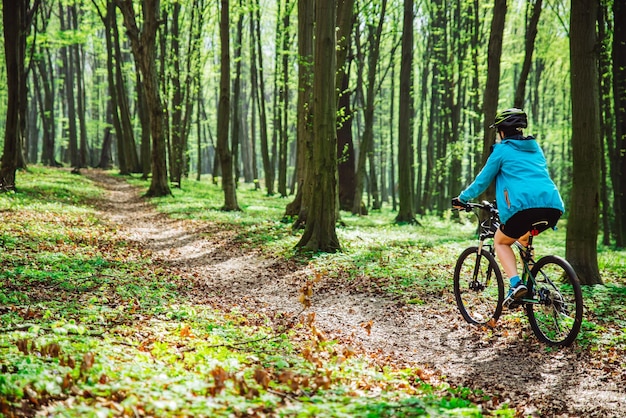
[0,0,40,190]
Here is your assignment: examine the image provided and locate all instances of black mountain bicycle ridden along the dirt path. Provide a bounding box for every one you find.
[454,201,583,346]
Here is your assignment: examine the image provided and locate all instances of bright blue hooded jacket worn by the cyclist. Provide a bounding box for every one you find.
[459,136,565,224]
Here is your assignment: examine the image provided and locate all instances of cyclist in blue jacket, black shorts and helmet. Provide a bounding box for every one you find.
[452,108,565,306]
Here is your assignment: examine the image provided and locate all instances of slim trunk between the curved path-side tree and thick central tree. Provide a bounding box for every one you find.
[217,0,241,211]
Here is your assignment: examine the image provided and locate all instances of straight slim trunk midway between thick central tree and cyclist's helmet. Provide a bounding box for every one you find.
[396,0,417,224]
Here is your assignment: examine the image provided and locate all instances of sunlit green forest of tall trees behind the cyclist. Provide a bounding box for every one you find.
[0,0,626,284]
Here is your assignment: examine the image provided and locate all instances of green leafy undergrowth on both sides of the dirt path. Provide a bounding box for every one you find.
[0,167,626,417]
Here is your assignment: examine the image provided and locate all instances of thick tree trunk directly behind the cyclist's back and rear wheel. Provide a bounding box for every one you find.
[566,0,602,284]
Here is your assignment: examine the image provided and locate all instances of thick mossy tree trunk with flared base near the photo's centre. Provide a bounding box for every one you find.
[296,0,341,252]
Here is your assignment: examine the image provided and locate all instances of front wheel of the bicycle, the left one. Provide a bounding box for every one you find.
[454,247,504,325]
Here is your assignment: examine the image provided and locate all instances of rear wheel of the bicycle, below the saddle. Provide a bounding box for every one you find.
[526,256,583,346]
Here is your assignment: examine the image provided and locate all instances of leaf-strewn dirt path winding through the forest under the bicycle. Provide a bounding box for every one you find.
[86,170,626,417]
